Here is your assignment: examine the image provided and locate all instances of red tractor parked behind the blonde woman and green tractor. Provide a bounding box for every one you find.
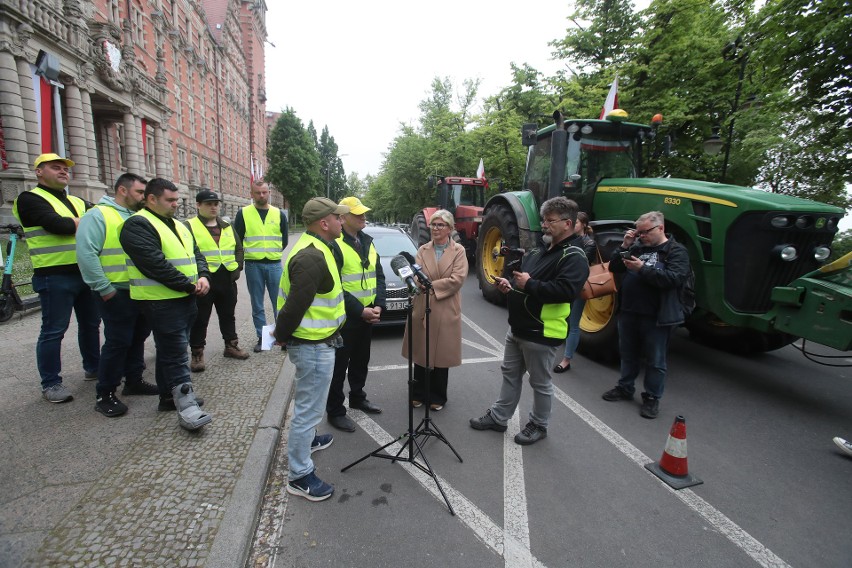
[408,176,486,258]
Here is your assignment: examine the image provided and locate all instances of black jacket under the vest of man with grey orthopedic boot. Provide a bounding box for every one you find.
[118,209,210,294]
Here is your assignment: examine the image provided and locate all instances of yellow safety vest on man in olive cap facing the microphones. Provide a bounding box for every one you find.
[278,233,346,341]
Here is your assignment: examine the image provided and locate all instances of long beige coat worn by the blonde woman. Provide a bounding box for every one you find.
[402,239,467,368]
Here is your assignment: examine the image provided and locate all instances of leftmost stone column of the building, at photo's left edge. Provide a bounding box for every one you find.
[0,51,30,170]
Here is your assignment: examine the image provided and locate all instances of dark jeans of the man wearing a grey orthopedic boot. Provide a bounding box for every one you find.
[139,296,198,398]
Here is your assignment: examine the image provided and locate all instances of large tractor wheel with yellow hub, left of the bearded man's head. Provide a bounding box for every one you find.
[476,205,520,306]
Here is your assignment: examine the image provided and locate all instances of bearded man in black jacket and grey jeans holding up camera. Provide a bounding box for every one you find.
[470,197,589,446]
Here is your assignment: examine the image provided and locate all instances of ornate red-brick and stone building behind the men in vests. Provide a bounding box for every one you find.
[0,0,274,224]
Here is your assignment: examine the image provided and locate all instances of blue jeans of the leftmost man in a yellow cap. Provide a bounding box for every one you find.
[32,274,101,390]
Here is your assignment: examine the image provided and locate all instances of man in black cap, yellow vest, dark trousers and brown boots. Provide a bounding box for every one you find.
[185,189,249,373]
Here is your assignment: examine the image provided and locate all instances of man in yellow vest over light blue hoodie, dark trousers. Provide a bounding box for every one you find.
[77,173,159,417]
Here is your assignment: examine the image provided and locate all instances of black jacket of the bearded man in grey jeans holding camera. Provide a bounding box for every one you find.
[508,237,589,345]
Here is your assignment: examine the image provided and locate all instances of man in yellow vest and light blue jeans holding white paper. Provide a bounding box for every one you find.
[234,180,287,353]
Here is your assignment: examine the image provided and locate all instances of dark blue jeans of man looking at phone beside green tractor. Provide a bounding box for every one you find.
[618,312,673,398]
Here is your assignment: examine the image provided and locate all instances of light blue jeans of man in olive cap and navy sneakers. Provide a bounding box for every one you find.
[287,343,336,481]
